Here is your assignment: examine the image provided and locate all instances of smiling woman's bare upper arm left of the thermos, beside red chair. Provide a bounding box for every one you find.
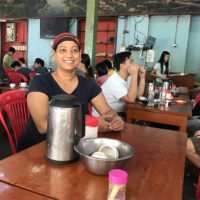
[27,92,49,134]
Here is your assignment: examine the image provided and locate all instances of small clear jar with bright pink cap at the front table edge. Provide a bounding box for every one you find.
[107,169,128,200]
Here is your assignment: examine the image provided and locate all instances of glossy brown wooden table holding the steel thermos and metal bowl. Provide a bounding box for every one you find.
[0,124,186,200]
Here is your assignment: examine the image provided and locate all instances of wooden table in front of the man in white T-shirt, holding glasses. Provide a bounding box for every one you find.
[126,97,192,132]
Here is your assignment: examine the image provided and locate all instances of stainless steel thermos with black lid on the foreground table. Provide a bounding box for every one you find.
[46,94,85,163]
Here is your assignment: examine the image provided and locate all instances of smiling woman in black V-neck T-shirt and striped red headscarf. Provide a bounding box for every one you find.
[18,33,124,151]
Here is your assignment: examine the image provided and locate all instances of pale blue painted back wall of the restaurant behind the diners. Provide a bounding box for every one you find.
[28,15,200,80]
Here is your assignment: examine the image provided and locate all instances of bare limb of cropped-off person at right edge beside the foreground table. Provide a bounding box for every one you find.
[186,130,200,168]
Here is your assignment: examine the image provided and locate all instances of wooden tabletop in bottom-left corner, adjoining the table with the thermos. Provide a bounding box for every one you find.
[0,182,52,200]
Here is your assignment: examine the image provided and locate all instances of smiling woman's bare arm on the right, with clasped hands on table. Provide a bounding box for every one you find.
[92,92,124,132]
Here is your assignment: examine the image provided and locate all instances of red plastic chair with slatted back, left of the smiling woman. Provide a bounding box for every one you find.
[0,90,29,154]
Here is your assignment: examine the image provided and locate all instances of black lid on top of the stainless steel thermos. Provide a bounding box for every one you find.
[49,94,77,108]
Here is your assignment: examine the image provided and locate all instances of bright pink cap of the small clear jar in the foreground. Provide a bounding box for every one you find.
[108,169,128,184]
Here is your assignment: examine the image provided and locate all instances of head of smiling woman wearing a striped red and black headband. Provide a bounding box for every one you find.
[52,33,81,70]
